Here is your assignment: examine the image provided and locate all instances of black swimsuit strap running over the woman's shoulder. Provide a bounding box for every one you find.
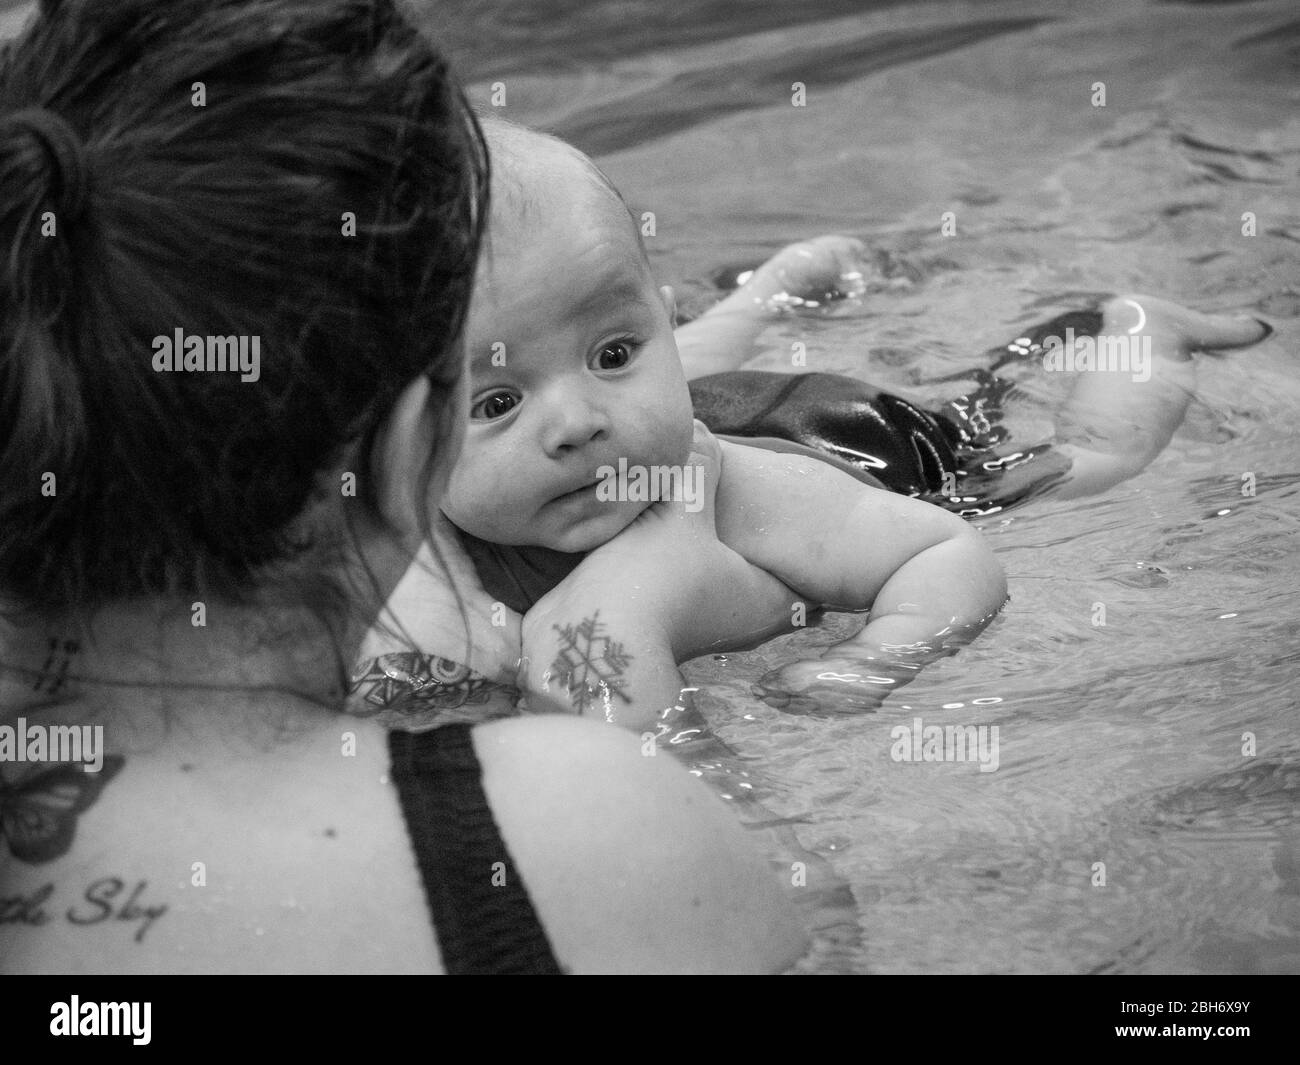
[389,724,563,975]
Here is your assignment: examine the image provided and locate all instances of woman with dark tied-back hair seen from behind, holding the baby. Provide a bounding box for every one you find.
[0,0,802,973]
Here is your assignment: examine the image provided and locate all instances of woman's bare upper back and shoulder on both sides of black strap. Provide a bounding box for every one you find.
[0,616,802,973]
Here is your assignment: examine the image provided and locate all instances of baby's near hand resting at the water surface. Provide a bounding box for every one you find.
[753,655,920,714]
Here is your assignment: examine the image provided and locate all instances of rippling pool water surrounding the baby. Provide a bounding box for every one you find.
[443,0,1300,973]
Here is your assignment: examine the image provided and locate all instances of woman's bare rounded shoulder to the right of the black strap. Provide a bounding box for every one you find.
[473,715,806,973]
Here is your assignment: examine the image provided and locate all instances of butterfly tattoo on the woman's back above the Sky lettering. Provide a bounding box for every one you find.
[0,754,126,865]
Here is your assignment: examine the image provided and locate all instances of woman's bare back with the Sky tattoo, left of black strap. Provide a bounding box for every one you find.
[0,701,439,973]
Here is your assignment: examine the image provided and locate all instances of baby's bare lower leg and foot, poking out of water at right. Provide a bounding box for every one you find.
[1044,295,1271,499]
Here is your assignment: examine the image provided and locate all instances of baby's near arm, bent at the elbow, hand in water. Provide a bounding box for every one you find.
[718,442,1006,709]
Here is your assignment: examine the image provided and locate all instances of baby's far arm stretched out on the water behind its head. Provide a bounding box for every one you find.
[676,237,868,381]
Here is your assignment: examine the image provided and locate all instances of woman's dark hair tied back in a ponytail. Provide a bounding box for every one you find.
[0,0,488,611]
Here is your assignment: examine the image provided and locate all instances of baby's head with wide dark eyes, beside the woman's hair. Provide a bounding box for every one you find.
[442,121,693,551]
